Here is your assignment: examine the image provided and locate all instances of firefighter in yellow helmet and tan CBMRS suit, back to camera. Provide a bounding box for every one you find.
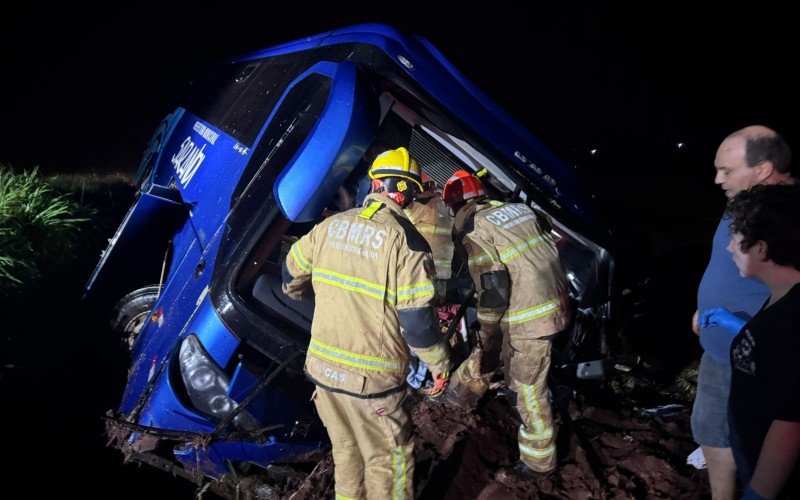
[283,147,451,499]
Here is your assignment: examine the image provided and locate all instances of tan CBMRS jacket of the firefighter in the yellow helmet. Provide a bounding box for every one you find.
[283,194,450,397]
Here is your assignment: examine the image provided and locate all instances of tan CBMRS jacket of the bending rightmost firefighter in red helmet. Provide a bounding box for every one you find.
[453,199,571,340]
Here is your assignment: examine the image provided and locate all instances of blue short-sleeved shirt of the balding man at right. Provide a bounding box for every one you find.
[697,214,769,364]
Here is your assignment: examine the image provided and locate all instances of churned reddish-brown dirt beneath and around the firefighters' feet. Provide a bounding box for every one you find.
[282,387,710,500]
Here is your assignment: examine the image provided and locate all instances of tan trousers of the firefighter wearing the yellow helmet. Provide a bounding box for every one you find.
[313,387,414,500]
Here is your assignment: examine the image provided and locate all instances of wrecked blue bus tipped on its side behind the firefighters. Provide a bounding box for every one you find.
[86,24,613,497]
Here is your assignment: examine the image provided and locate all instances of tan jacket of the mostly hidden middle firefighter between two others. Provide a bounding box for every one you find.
[404,190,453,280]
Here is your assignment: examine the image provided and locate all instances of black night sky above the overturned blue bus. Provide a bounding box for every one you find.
[0,0,800,215]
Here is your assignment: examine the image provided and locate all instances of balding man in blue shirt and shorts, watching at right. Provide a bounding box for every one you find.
[692,125,793,500]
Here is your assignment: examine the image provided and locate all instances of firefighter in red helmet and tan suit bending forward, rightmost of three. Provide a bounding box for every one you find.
[439,170,571,475]
